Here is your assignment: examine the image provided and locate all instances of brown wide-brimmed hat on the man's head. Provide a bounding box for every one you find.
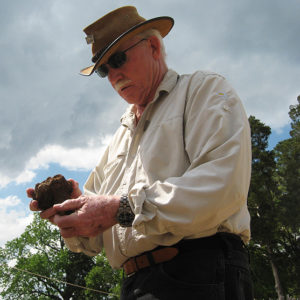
[80,6,174,76]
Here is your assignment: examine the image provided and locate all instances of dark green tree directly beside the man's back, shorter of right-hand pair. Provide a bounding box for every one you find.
[248,116,284,299]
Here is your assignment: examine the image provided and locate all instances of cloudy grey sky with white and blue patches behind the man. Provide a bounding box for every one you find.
[0,0,300,246]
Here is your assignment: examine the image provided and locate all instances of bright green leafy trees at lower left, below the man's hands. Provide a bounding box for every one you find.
[0,214,120,300]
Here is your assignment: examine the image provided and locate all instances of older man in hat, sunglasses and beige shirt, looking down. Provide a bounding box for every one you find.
[27,6,252,300]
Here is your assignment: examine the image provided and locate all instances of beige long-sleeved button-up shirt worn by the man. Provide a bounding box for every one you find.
[66,70,251,268]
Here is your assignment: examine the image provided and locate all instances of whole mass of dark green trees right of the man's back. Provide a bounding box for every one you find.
[248,97,300,299]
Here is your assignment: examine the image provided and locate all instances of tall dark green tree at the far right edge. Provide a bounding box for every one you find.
[274,96,300,296]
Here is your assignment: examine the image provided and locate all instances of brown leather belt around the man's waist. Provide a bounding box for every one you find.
[123,247,179,276]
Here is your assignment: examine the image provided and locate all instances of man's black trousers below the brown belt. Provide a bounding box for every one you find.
[121,234,253,300]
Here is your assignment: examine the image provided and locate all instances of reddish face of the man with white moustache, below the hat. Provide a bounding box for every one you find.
[108,37,162,106]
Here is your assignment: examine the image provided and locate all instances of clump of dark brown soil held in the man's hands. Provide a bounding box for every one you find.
[33,174,73,210]
